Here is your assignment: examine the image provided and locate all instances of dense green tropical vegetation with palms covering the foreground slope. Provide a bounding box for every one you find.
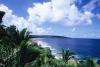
[0,12,100,67]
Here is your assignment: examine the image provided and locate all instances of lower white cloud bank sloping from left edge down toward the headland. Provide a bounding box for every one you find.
[0,4,51,35]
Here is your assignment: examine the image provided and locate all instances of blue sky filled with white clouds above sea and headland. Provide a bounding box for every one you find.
[0,0,100,38]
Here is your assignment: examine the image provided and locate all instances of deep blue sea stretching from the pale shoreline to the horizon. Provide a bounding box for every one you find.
[32,38,100,58]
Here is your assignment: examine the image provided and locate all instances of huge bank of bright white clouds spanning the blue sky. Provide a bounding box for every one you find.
[0,0,94,35]
